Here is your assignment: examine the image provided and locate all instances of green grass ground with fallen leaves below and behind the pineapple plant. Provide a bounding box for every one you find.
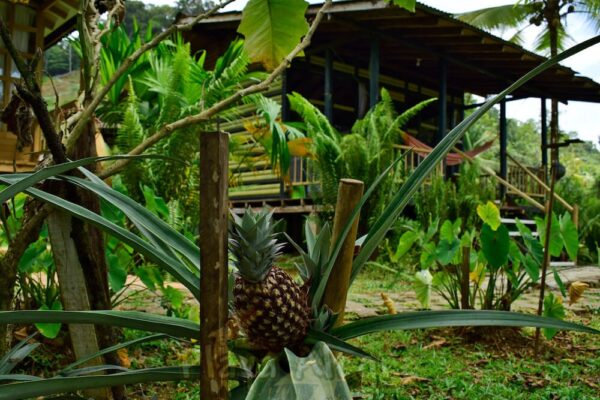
[14,268,600,400]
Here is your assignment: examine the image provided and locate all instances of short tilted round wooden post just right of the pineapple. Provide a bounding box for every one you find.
[323,179,365,326]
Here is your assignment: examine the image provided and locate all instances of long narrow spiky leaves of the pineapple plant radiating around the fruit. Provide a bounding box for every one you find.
[0,37,600,399]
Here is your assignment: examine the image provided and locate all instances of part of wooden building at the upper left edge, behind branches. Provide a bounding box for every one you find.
[0,0,79,172]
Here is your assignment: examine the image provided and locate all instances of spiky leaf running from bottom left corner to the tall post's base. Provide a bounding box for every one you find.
[0,366,200,400]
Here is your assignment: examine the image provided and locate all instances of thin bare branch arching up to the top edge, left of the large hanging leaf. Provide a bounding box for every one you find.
[63,0,236,151]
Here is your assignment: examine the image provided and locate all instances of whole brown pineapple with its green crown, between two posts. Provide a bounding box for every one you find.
[229,209,310,352]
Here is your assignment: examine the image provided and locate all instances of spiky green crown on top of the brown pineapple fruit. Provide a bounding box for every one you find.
[229,208,284,282]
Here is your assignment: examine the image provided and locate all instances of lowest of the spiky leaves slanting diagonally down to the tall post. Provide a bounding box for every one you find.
[0,176,200,300]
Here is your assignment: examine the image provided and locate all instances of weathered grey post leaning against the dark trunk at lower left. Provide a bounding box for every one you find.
[48,211,112,399]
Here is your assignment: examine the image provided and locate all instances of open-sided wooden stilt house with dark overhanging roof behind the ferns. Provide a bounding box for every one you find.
[184,0,600,216]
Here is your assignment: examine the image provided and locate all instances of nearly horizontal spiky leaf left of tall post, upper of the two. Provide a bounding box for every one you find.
[0,310,200,339]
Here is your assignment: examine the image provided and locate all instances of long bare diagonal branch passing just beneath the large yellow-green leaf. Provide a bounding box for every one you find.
[98,0,332,179]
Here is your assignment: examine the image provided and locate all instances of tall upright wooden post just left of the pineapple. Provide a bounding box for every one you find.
[200,132,229,400]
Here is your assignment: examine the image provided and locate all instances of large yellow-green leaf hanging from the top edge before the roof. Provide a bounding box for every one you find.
[238,0,308,70]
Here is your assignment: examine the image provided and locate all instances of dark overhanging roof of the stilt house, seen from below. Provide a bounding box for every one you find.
[180,0,600,102]
